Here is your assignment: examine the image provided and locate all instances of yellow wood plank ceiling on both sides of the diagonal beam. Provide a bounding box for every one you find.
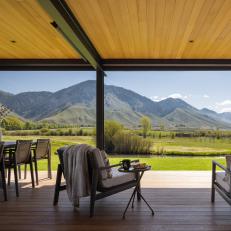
[0,0,231,59]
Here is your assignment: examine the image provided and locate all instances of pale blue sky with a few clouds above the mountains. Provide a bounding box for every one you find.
[0,71,231,112]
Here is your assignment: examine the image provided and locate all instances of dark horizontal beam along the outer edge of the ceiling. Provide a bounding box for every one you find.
[0,59,231,71]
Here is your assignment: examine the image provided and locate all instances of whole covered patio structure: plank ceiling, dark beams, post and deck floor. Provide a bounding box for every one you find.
[0,0,231,231]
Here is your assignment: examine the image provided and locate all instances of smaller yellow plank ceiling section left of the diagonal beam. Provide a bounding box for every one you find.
[0,0,79,59]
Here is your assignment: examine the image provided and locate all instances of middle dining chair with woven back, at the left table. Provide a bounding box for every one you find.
[5,140,35,197]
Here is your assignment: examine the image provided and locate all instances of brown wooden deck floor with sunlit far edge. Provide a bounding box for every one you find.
[0,172,231,231]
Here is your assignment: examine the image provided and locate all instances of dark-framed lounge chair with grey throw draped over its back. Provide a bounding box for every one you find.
[53,147,140,217]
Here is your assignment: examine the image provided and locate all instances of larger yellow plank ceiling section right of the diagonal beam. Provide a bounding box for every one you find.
[66,0,231,59]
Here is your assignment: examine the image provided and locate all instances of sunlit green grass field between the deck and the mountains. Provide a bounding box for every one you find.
[4,136,228,170]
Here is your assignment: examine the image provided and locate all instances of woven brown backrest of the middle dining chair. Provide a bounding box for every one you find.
[15,140,32,164]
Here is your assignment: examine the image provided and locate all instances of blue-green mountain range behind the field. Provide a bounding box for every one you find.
[0,80,231,129]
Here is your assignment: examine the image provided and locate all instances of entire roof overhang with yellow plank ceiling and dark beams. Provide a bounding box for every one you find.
[0,0,231,71]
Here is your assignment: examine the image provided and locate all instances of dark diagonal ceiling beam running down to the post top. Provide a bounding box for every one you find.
[38,0,103,70]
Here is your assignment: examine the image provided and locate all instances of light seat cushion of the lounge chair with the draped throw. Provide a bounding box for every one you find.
[102,168,136,188]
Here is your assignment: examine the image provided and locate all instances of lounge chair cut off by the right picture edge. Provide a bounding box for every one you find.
[211,161,231,205]
